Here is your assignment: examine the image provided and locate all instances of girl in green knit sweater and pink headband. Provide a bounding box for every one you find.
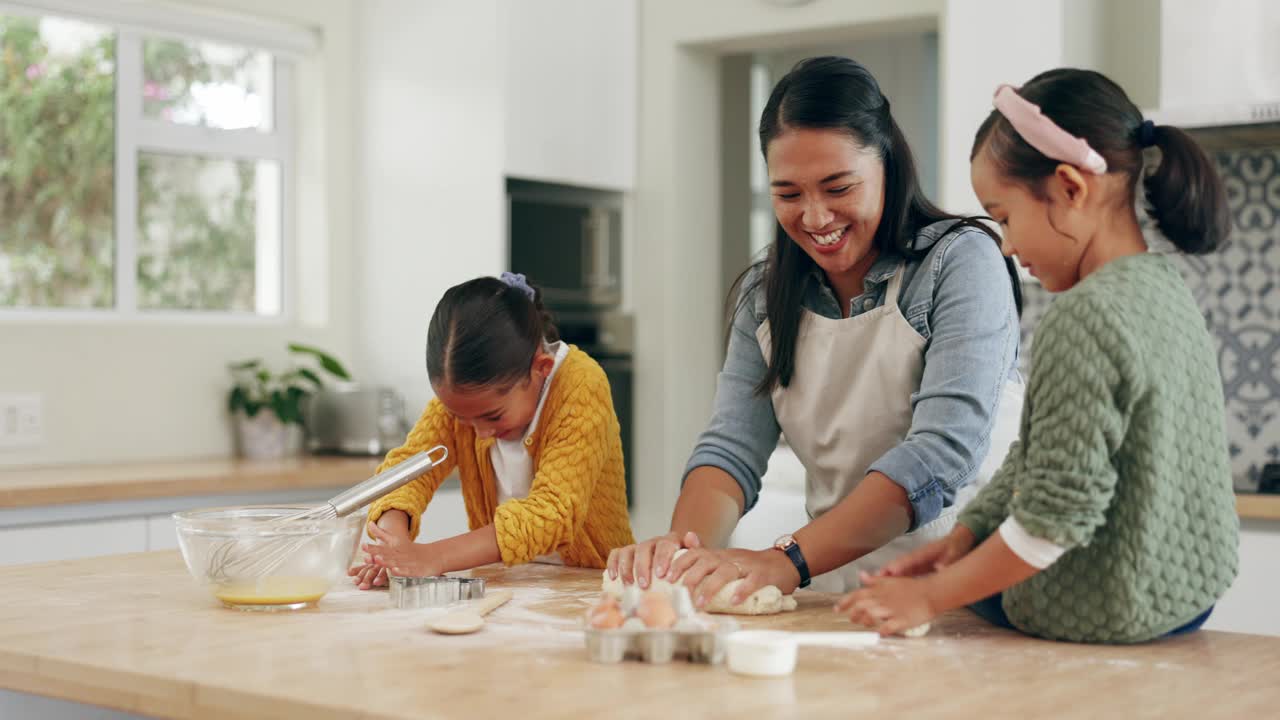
[837,69,1239,643]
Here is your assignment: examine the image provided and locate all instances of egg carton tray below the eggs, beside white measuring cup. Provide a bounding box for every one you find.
[582,618,739,665]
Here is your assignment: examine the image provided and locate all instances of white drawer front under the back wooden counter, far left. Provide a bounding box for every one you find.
[0,518,147,565]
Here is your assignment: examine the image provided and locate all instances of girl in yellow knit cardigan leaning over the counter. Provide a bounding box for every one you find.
[351,273,635,589]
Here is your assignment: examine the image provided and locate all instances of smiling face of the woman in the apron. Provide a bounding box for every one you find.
[765,128,884,278]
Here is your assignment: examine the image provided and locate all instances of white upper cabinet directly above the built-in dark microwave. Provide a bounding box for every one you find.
[499,0,637,190]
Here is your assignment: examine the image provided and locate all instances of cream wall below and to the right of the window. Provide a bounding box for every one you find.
[0,0,355,465]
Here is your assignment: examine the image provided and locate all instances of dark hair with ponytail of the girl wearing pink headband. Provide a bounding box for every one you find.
[970,68,1231,254]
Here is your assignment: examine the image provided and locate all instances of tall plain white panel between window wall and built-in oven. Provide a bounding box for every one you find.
[351,0,507,419]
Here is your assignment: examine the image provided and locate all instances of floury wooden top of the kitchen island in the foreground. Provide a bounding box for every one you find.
[0,552,1280,720]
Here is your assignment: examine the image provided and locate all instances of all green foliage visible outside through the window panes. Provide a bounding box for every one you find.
[0,15,267,311]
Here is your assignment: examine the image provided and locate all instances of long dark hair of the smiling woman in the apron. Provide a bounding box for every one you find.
[730,56,1023,395]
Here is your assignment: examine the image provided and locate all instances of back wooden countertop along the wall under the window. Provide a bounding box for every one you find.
[0,455,381,509]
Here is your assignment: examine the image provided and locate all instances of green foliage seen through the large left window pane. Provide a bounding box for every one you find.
[0,15,115,307]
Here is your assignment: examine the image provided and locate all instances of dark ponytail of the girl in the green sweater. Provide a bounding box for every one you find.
[1142,126,1231,255]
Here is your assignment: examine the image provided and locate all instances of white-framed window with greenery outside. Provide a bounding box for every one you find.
[0,4,292,316]
